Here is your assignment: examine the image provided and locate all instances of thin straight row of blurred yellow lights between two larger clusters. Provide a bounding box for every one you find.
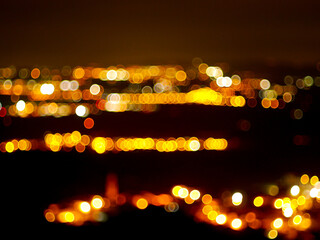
[0,131,228,154]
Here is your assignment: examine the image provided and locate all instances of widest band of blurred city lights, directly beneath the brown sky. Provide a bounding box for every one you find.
[0,61,320,119]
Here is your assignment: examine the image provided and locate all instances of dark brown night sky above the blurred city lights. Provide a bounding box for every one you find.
[0,0,320,66]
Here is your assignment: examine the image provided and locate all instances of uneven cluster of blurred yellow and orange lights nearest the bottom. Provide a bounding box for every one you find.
[44,174,320,239]
